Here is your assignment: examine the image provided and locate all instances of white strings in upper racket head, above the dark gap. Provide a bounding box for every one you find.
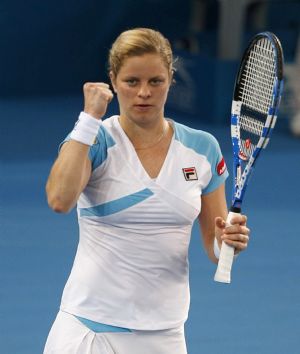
[239,39,275,114]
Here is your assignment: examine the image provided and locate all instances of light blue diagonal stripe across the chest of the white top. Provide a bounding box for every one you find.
[79,188,154,217]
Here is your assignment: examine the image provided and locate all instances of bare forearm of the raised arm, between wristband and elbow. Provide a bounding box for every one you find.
[46,140,91,213]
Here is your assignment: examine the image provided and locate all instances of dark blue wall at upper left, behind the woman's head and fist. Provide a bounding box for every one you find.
[0,0,189,97]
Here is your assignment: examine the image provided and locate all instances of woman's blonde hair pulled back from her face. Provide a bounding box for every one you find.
[108,28,173,77]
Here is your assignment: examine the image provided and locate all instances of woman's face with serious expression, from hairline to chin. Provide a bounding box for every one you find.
[110,54,172,125]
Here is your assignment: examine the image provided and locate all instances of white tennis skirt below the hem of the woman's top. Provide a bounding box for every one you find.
[44,311,187,354]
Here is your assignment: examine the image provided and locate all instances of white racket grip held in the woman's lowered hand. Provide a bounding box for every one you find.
[214,211,238,284]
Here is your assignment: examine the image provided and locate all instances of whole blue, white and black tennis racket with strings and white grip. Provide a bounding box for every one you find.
[214,32,283,283]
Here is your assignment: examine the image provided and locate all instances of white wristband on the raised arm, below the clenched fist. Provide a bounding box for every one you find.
[70,112,102,146]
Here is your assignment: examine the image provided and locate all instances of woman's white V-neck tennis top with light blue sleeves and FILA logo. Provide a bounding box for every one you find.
[61,116,228,330]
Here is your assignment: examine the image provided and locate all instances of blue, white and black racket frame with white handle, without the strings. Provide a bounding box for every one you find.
[214,32,283,283]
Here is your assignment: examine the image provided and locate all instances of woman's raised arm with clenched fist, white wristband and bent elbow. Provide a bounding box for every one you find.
[46,83,113,213]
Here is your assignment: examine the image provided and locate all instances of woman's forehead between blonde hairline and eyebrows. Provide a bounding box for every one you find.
[118,54,168,76]
